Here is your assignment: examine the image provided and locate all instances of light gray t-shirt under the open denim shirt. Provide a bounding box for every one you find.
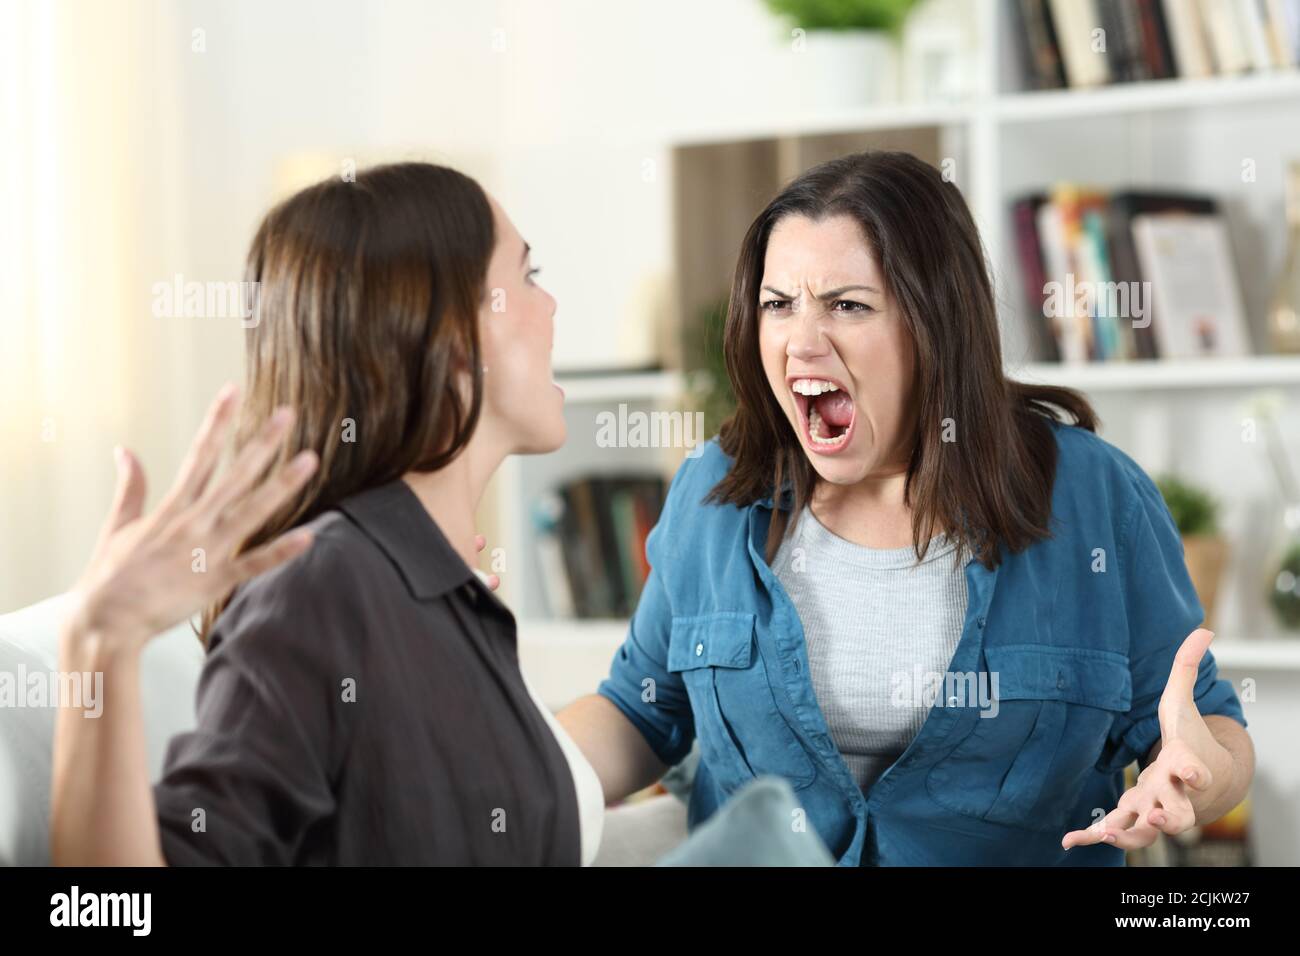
[772,507,967,792]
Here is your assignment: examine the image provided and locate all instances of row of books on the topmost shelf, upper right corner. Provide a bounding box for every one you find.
[1017,0,1300,90]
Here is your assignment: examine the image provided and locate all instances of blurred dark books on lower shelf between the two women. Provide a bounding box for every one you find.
[532,475,666,618]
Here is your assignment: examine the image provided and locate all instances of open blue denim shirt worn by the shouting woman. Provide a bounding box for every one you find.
[598,421,1245,866]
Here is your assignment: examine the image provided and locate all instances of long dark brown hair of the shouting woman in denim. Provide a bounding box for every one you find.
[709,151,1097,568]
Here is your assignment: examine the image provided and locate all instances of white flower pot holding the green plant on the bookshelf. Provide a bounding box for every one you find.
[794,30,898,112]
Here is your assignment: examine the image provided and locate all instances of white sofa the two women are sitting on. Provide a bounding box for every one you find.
[0,596,686,866]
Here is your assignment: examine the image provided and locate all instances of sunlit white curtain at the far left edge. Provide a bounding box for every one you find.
[0,0,192,613]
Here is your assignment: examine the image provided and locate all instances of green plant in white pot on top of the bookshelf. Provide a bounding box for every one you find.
[764,0,915,109]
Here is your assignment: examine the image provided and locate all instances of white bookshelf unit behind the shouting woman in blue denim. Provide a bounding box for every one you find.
[499,0,1300,667]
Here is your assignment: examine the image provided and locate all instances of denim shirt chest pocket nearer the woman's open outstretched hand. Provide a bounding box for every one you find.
[926,644,1132,831]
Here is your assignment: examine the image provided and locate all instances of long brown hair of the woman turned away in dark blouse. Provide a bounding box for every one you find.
[199,163,495,644]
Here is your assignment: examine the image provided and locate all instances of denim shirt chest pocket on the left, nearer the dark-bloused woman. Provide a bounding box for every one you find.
[667,611,816,793]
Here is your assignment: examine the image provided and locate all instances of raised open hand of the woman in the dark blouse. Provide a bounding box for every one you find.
[69,385,317,646]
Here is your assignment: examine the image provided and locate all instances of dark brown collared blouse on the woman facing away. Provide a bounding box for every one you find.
[153,481,580,866]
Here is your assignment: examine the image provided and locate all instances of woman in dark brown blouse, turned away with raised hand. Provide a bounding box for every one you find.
[51,164,580,865]
